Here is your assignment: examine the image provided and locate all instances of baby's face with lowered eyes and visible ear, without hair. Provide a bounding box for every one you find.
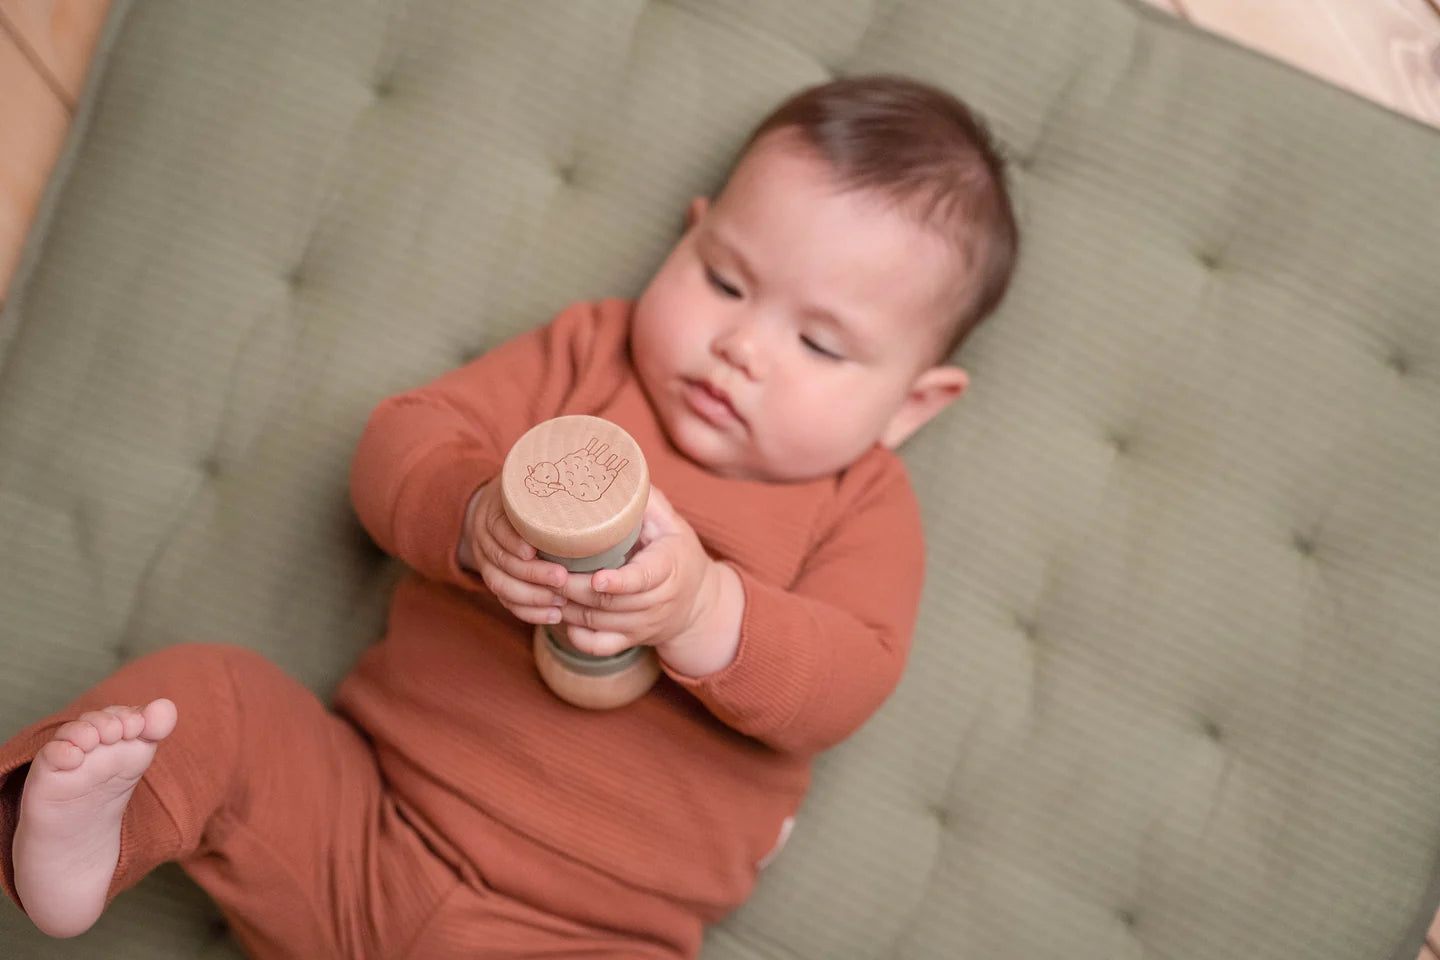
[631,131,965,481]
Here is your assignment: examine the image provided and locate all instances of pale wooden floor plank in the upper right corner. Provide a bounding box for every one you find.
[1184,0,1440,125]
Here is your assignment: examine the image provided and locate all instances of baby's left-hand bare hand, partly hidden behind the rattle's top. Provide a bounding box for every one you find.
[458,481,567,623]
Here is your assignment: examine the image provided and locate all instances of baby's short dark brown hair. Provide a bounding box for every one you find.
[740,75,1020,361]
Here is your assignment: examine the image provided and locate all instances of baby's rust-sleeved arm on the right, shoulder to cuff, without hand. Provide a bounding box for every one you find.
[667,465,924,753]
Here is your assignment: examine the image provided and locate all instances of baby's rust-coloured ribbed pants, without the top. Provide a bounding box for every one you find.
[0,645,677,960]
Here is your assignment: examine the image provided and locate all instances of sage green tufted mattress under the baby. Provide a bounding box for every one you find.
[0,0,1440,960]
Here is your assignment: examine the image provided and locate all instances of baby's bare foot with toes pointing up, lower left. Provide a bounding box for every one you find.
[13,699,176,937]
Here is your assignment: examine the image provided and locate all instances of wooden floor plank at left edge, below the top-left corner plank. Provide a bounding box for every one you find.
[0,29,69,296]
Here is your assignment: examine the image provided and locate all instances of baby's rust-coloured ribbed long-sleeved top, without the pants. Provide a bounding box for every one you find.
[337,299,924,938]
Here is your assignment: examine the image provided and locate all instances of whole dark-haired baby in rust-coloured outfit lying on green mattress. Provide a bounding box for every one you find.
[0,76,1018,960]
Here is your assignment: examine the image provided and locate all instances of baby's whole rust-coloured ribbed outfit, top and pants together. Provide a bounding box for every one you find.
[0,301,923,957]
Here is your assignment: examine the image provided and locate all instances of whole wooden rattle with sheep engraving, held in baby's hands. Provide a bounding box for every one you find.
[500,416,660,710]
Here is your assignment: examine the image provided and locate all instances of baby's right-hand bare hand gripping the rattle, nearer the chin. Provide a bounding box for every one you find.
[552,486,717,656]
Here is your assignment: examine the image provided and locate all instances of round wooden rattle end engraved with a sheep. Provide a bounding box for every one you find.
[500,416,649,571]
